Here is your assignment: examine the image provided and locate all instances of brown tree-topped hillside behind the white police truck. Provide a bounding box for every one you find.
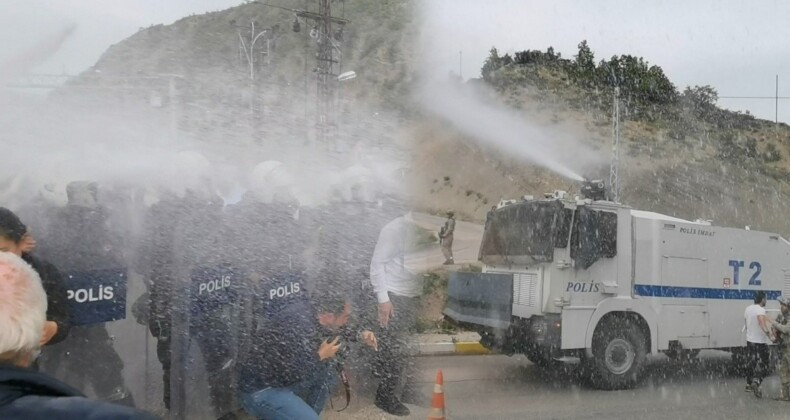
[415,43,790,236]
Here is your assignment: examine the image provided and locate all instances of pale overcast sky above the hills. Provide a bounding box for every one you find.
[0,0,790,122]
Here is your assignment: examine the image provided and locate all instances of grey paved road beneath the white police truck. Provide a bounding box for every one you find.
[322,352,790,420]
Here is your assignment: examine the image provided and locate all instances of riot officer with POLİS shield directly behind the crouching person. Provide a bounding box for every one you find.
[227,198,320,392]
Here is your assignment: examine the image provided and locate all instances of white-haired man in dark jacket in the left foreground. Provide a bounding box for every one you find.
[0,252,157,420]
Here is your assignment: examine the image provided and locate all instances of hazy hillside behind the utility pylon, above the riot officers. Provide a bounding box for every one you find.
[61,0,417,151]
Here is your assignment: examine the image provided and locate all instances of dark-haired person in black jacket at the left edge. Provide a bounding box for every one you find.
[0,207,71,344]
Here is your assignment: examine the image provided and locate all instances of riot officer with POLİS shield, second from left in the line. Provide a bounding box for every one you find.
[138,193,238,415]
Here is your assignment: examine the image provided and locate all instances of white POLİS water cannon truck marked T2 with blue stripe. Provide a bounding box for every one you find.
[445,181,790,389]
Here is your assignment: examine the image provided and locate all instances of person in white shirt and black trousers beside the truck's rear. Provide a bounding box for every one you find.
[744,291,773,398]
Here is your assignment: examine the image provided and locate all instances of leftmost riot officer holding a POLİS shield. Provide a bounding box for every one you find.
[32,181,134,406]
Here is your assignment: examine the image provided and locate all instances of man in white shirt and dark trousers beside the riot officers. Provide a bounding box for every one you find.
[370,213,423,416]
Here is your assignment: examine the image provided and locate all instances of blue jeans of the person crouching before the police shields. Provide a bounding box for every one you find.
[241,362,339,420]
